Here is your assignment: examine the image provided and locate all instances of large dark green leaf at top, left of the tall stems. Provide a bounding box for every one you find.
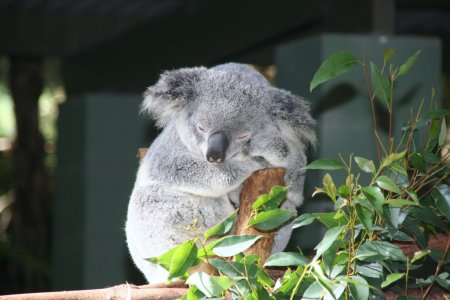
[309,51,358,92]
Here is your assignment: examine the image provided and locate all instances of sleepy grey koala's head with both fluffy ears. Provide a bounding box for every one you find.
[142,63,314,164]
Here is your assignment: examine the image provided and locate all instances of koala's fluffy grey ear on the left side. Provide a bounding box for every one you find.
[141,67,207,127]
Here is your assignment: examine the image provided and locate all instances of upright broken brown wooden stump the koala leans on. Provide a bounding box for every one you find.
[235,168,285,264]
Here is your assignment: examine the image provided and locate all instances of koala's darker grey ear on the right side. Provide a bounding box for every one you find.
[268,88,317,148]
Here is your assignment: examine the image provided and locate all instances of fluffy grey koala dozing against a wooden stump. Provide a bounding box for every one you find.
[126,63,316,283]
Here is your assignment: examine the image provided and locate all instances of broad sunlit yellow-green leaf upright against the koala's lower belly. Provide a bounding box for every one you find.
[169,240,198,279]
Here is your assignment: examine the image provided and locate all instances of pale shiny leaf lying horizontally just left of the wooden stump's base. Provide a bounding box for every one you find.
[212,234,261,257]
